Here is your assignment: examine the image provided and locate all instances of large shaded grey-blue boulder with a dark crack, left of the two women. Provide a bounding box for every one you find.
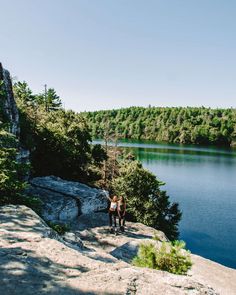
[27,176,107,222]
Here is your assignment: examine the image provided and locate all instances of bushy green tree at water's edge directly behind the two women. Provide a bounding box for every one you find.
[112,160,181,240]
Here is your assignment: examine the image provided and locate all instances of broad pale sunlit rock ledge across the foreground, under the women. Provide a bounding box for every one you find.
[0,206,236,295]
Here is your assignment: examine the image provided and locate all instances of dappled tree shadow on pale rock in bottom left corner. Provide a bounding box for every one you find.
[0,247,118,295]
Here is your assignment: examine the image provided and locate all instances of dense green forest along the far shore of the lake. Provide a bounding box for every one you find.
[83,107,236,146]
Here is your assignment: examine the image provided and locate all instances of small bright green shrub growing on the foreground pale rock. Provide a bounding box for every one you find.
[133,241,192,275]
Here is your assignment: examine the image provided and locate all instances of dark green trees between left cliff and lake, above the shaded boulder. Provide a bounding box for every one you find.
[14,82,106,182]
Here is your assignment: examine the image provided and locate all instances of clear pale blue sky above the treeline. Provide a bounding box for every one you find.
[0,0,236,111]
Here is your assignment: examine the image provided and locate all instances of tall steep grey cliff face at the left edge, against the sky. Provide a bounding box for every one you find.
[0,63,20,136]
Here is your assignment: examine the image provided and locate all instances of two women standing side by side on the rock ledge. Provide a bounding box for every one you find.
[108,196,126,231]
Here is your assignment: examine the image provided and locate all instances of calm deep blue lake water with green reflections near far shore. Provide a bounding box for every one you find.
[96,140,236,268]
